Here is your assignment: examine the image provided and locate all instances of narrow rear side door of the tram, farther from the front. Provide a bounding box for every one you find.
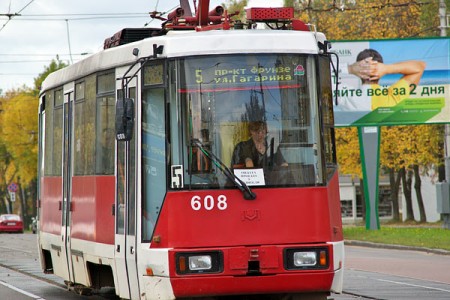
[61,89,74,282]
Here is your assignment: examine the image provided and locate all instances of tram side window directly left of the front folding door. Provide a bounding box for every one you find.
[95,71,115,175]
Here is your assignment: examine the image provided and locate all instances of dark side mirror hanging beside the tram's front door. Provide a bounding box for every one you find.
[116,98,134,141]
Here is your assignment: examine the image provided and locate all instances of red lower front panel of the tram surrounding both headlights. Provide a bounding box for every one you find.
[169,243,334,297]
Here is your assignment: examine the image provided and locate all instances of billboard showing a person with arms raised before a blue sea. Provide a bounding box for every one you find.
[332,38,450,126]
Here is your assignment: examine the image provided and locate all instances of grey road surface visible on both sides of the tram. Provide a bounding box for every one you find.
[0,234,450,300]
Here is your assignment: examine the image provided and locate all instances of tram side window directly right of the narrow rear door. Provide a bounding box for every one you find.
[74,76,96,175]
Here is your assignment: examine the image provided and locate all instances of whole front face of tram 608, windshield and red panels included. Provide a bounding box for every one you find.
[135,29,343,299]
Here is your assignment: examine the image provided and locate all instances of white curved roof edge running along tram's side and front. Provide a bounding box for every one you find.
[41,30,325,91]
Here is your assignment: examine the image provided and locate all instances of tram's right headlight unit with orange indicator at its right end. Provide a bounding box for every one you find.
[284,248,329,270]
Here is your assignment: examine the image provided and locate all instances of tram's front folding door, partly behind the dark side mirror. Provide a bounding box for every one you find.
[115,76,139,299]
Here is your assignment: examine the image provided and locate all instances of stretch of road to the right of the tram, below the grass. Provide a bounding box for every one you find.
[333,246,450,300]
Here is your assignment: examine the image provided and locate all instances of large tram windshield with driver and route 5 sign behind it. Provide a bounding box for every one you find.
[169,54,323,189]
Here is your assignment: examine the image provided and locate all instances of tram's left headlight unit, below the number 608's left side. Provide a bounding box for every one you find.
[175,251,223,274]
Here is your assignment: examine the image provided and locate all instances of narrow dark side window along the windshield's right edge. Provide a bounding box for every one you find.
[319,56,336,178]
